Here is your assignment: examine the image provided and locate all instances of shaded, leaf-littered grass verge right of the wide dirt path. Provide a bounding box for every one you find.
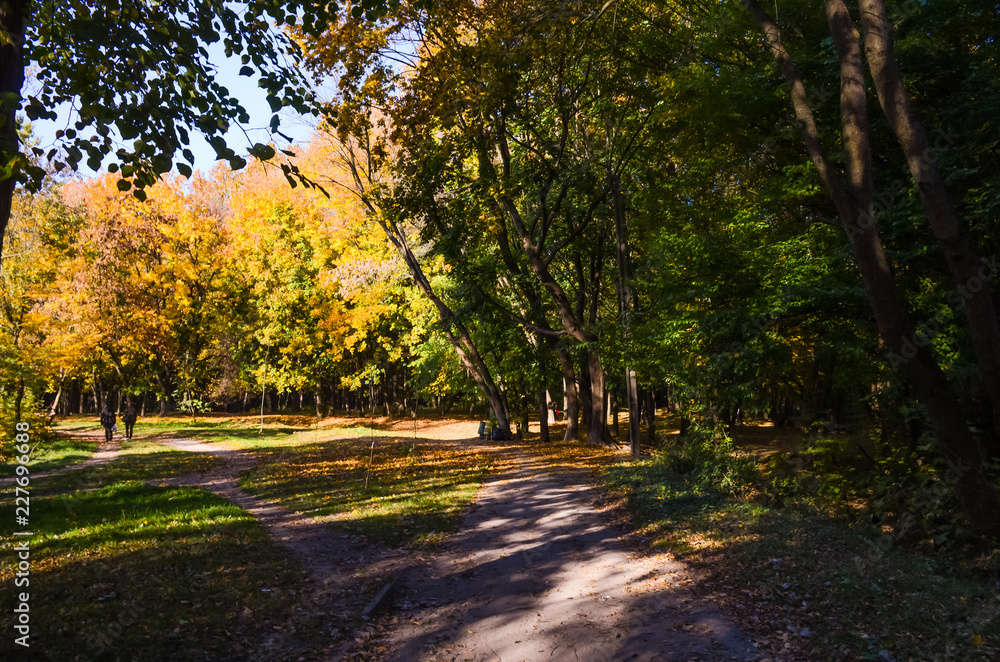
[605,459,1000,662]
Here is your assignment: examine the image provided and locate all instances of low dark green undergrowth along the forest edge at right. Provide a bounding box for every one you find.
[653,424,1000,548]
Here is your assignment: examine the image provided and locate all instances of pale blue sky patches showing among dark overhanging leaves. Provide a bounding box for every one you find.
[29,44,314,176]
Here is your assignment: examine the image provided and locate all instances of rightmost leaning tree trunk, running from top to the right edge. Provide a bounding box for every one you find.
[858,0,1000,440]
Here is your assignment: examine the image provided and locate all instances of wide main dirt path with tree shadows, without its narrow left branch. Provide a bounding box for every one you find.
[366,454,758,662]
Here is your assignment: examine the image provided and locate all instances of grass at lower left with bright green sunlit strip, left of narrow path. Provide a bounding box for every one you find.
[0,482,329,662]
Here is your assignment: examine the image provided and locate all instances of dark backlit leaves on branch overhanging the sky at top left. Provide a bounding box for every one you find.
[10,0,356,200]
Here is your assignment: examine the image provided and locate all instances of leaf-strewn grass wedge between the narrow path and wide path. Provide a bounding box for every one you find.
[240,438,493,546]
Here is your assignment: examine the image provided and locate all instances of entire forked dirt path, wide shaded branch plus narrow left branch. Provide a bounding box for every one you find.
[33,424,760,662]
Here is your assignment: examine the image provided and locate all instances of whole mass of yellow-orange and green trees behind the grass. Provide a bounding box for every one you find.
[2,0,1000,534]
